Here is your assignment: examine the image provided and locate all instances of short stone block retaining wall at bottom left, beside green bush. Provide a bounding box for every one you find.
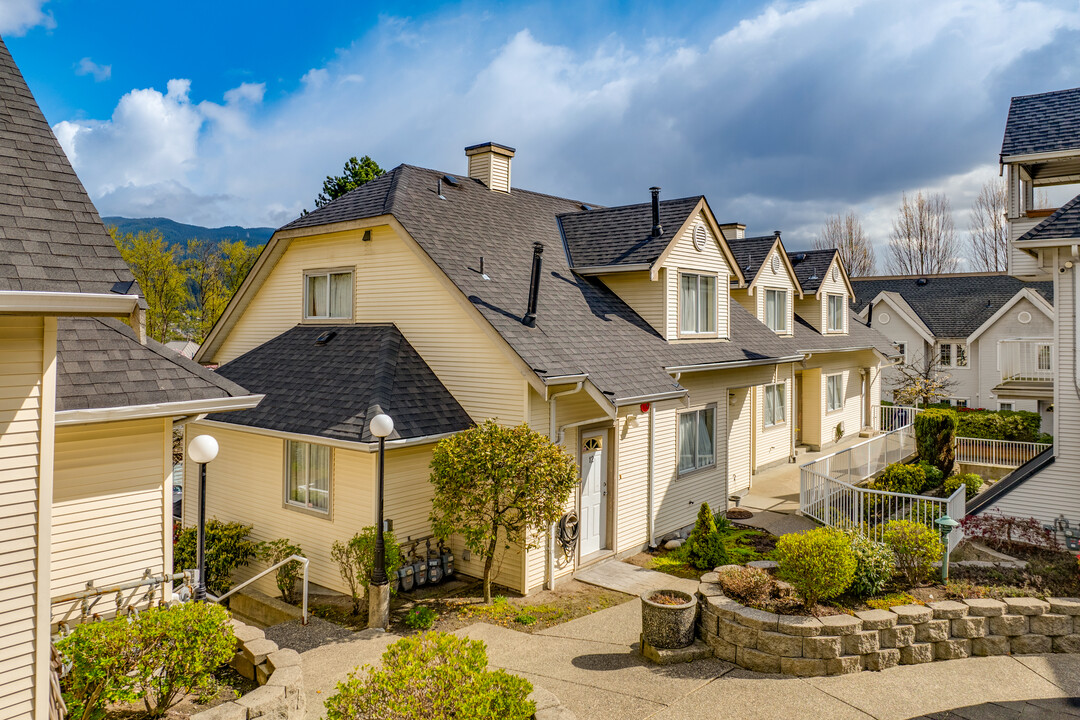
[192,619,305,720]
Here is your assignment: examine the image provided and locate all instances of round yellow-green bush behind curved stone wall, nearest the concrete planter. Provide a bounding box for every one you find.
[777,528,858,609]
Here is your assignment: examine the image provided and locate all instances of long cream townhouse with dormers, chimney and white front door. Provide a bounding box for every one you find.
[192,144,894,593]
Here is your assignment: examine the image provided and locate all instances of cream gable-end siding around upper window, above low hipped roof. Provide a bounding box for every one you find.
[215,226,525,424]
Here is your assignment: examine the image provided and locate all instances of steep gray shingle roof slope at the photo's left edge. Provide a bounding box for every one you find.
[0,35,138,293]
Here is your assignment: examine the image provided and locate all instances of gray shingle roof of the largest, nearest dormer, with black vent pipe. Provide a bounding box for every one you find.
[558,195,701,268]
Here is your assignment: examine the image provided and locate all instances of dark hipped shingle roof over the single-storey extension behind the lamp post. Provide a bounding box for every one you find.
[211,324,472,443]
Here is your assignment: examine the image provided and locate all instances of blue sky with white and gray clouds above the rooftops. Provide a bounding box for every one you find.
[6,0,1080,262]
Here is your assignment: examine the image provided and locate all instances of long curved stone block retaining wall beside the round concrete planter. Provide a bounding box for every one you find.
[698,573,1080,677]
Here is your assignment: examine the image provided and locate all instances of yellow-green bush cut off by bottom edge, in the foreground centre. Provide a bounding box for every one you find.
[326,633,536,720]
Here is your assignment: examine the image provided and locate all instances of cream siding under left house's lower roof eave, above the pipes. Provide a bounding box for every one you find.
[51,418,173,622]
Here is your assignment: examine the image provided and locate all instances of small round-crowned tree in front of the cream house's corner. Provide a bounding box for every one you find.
[431,420,578,602]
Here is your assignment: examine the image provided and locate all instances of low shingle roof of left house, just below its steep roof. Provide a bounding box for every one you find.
[56,317,248,410]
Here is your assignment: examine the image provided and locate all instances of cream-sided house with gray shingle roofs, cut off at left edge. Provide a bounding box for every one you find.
[0,41,258,720]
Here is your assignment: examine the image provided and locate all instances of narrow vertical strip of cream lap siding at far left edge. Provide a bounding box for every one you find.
[0,316,48,720]
